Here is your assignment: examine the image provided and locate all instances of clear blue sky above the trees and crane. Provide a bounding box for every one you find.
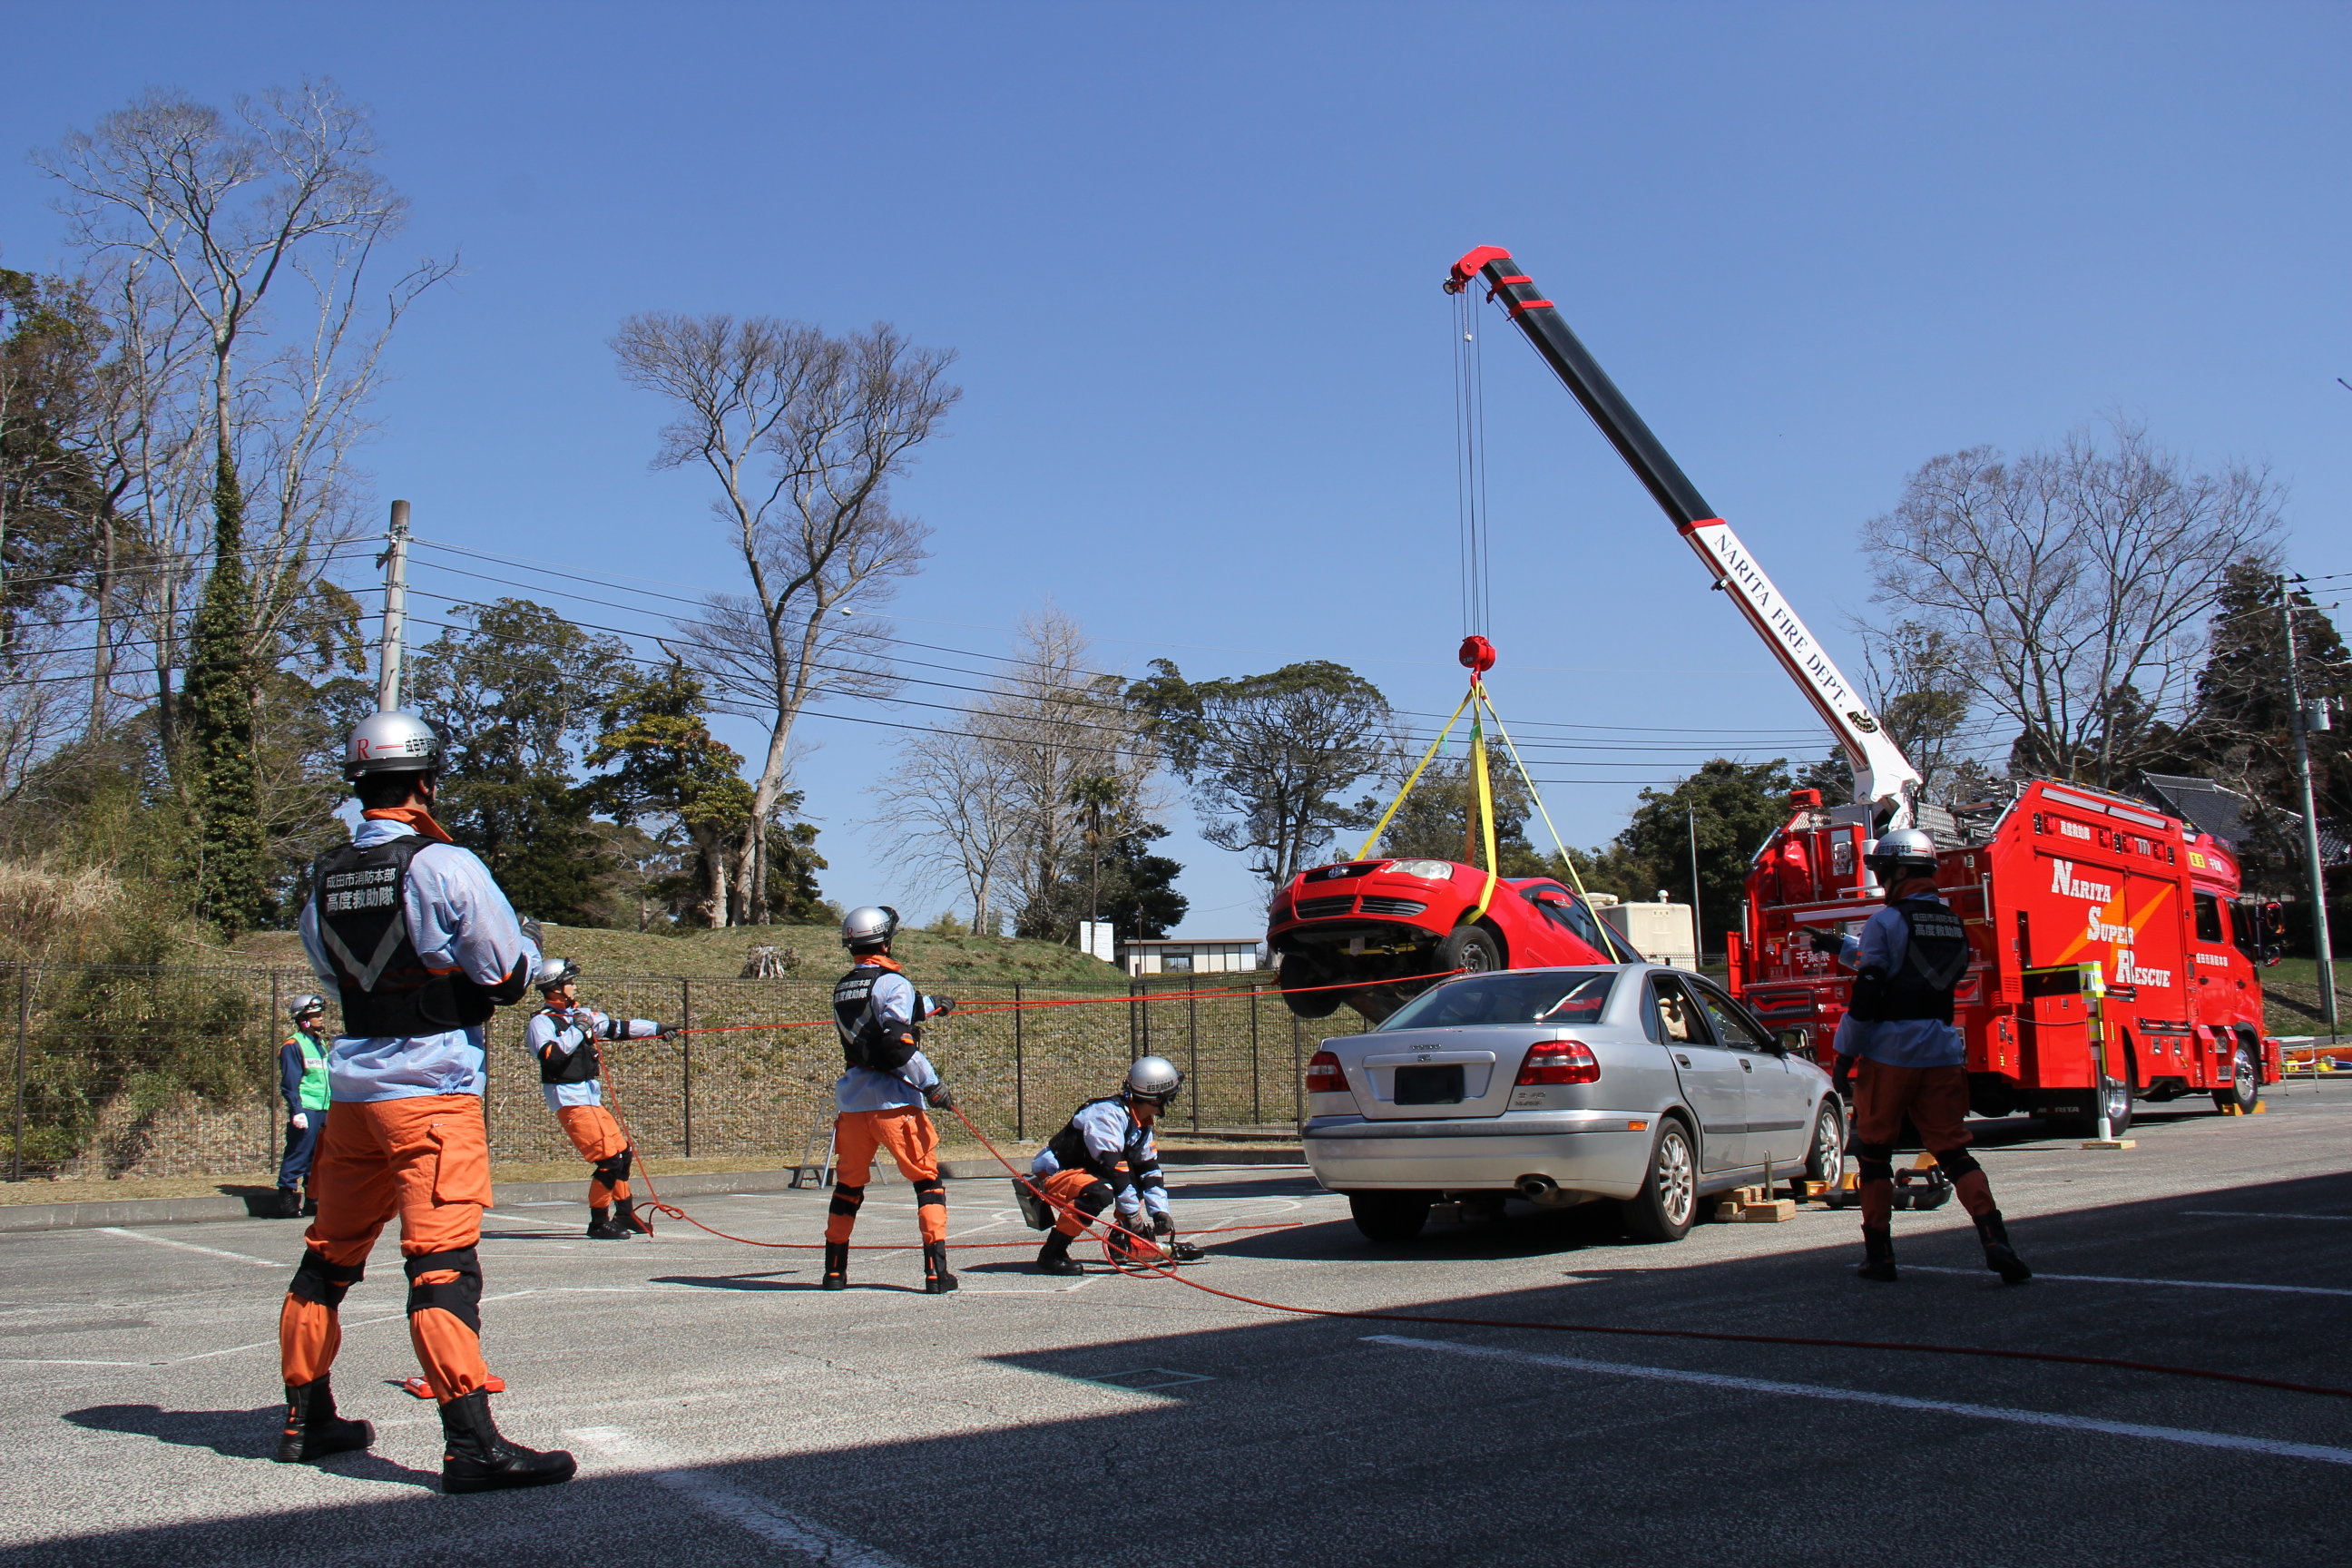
[0,3,2352,936]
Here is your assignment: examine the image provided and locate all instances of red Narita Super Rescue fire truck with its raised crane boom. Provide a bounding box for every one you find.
[1446,247,2279,1131]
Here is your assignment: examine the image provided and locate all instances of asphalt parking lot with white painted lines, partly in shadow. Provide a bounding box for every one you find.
[0,1083,2352,1568]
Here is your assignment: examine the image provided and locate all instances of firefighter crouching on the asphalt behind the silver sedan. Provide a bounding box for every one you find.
[1014,1055,1200,1274]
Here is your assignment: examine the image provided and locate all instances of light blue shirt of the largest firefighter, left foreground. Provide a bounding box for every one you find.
[301,820,539,1102]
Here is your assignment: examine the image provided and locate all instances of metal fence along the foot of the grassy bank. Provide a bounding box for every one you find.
[0,964,1362,1181]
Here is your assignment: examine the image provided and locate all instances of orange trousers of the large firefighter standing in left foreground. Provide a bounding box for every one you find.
[278,1095,492,1401]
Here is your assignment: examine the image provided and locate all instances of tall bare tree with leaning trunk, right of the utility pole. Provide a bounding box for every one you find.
[612,310,962,924]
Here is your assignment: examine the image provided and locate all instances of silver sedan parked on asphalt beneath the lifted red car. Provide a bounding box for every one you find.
[1303,964,1847,1241]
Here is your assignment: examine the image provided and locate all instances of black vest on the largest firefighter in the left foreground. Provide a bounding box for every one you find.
[310,832,494,1037]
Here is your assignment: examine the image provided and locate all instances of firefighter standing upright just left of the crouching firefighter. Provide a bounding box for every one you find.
[821,905,955,1295]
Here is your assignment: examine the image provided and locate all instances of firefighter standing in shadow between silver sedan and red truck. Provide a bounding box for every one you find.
[1808,828,2034,1286]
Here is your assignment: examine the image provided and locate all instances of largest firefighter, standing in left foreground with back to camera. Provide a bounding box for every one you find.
[278,712,573,1493]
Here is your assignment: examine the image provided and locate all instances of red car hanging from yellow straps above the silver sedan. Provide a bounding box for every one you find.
[1265,860,1642,1023]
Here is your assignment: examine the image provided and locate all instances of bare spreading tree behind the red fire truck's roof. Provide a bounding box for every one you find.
[1863,421,2279,788]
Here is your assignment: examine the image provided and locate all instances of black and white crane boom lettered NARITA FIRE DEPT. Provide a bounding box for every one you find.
[1446,244,1919,828]
